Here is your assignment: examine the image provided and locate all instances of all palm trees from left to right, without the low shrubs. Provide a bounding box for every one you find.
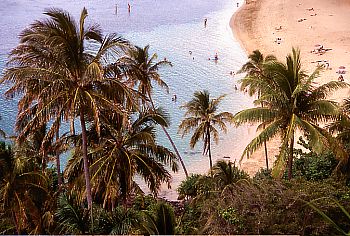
[0,4,350,234]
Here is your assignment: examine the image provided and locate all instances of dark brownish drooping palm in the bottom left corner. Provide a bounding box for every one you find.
[0,140,54,234]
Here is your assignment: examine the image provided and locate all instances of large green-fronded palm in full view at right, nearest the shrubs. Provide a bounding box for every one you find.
[234,48,347,179]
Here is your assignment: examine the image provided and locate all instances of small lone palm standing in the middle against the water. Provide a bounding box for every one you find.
[179,90,233,175]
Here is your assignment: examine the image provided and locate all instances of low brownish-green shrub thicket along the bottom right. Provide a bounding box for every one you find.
[179,175,350,235]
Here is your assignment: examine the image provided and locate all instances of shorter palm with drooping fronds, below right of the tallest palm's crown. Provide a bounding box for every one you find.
[66,107,178,209]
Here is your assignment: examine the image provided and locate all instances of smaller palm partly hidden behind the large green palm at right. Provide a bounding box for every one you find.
[238,50,276,169]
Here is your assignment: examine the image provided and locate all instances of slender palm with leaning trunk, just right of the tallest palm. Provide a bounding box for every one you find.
[124,45,188,177]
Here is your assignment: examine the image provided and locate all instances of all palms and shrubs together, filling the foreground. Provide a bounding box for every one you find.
[0,6,350,235]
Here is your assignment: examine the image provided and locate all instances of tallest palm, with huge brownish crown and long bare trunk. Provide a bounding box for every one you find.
[3,8,131,208]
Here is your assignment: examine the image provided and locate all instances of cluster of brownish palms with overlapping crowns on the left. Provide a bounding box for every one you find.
[0,8,189,233]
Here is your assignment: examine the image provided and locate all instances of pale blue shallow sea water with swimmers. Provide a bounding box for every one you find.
[0,0,254,199]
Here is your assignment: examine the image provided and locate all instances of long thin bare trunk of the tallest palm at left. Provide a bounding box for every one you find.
[80,108,92,210]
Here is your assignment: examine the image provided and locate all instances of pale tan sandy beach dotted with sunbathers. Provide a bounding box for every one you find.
[230,0,350,173]
